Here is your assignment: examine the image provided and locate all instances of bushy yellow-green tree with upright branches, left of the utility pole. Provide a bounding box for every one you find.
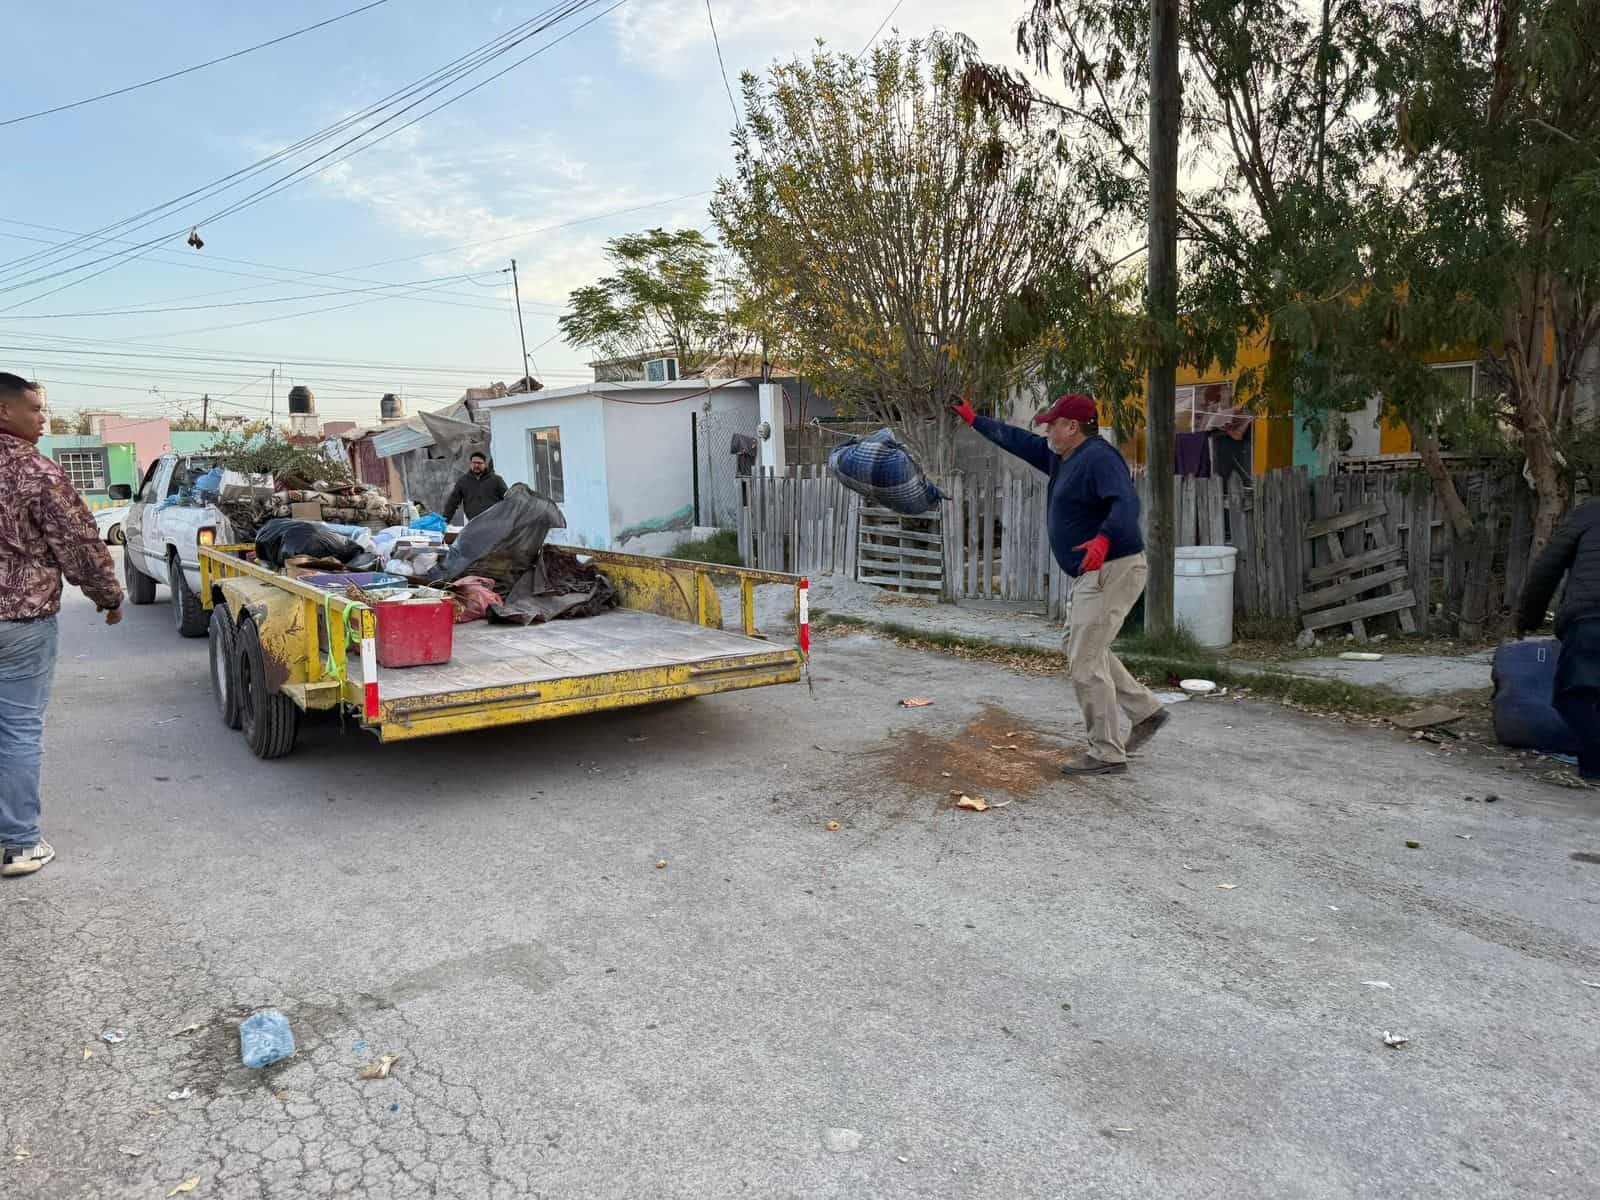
[712,35,1091,470]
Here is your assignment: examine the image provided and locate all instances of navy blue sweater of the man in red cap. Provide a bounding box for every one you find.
[973,416,1144,578]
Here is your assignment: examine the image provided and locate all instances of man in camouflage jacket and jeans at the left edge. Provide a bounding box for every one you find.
[0,371,122,875]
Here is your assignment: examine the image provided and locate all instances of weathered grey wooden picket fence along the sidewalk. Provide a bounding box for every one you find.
[739,464,1533,632]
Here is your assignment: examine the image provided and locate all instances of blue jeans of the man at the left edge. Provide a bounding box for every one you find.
[0,616,56,850]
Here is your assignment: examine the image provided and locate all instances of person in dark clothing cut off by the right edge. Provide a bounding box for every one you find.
[1517,501,1600,781]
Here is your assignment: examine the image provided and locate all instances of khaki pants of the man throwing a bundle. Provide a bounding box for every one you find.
[1067,554,1162,763]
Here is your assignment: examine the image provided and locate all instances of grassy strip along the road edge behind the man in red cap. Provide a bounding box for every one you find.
[813,613,1418,717]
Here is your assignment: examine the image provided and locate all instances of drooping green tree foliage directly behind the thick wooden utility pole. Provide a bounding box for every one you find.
[966,0,1384,432]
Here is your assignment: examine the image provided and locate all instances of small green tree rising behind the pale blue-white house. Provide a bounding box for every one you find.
[560,229,754,376]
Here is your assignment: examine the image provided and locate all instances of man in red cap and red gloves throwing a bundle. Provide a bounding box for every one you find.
[954,395,1166,774]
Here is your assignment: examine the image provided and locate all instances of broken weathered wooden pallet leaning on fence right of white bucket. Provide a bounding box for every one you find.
[1299,501,1416,642]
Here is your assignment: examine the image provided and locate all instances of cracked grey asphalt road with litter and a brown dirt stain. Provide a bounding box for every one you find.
[0,560,1600,1198]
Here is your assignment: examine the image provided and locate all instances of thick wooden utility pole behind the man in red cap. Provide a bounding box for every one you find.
[1144,0,1182,634]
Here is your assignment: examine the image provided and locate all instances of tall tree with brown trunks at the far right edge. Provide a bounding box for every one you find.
[1368,0,1600,547]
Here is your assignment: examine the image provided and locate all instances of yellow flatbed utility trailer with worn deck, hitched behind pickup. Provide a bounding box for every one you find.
[200,546,810,758]
